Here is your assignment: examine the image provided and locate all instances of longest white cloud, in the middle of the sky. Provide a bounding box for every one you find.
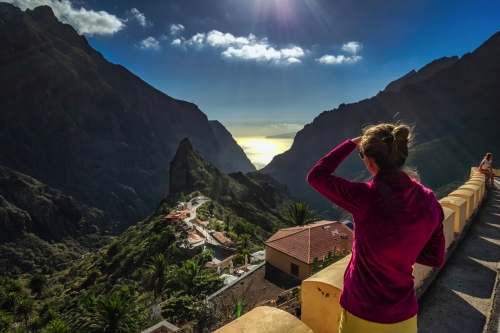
[178,30,307,65]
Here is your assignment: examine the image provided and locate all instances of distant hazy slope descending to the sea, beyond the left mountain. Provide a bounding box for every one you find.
[209,120,256,173]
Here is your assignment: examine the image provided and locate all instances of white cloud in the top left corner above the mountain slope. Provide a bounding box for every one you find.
[2,0,125,36]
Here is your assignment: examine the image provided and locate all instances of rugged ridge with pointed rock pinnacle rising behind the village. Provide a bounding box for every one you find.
[169,138,291,232]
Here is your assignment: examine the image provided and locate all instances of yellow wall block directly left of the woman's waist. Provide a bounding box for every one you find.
[300,255,351,333]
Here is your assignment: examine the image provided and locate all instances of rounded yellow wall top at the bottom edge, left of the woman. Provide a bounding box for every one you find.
[214,306,313,333]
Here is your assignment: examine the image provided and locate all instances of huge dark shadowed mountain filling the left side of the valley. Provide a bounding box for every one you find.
[0,3,251,230]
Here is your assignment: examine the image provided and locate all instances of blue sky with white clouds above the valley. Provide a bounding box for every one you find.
[8,0,500,136]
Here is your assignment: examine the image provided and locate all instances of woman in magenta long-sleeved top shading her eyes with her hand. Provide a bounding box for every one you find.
[307,124,445,333]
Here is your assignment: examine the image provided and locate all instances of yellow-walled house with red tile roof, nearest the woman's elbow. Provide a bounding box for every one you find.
[266,221,353,280]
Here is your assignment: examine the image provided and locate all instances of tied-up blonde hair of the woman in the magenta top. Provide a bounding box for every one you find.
[359,123,413,169]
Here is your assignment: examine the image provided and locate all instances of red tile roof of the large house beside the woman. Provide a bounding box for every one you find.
[266,221,354,264]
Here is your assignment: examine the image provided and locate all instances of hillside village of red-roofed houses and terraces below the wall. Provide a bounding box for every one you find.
[149,196,354,333]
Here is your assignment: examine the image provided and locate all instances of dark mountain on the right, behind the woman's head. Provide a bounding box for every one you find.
[260,33,500,213]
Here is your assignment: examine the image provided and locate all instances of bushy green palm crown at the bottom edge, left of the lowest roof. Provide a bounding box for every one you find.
[76,292,141,333]
